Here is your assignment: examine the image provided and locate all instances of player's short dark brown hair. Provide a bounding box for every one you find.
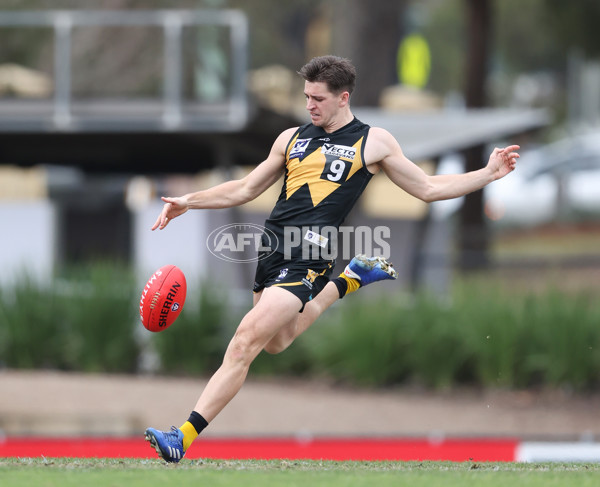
[298,55,356,94]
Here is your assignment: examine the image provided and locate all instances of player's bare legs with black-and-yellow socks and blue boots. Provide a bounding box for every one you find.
[146,255,398,463]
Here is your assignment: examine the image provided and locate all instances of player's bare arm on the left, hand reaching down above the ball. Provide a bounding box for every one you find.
[152,128,296,230]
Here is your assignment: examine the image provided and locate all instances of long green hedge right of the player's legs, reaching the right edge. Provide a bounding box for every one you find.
[294,284,600,390]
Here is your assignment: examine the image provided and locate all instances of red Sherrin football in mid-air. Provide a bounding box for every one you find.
[140,265,187,331]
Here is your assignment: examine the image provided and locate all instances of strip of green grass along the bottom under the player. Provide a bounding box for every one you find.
[0,458,600,487]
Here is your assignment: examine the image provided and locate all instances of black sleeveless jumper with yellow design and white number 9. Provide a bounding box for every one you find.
[265,118,372,260]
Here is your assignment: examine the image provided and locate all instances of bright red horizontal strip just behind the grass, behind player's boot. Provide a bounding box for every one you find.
[0,438,519,462]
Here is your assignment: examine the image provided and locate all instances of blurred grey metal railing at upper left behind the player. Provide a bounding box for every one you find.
[0,10,248,132]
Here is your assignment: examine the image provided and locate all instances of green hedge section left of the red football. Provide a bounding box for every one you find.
[0,264,139,372]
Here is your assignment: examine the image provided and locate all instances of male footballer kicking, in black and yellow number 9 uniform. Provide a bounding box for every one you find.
[145,56,519,462]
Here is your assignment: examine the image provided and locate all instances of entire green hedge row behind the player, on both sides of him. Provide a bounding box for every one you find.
[0,264,600,390]
